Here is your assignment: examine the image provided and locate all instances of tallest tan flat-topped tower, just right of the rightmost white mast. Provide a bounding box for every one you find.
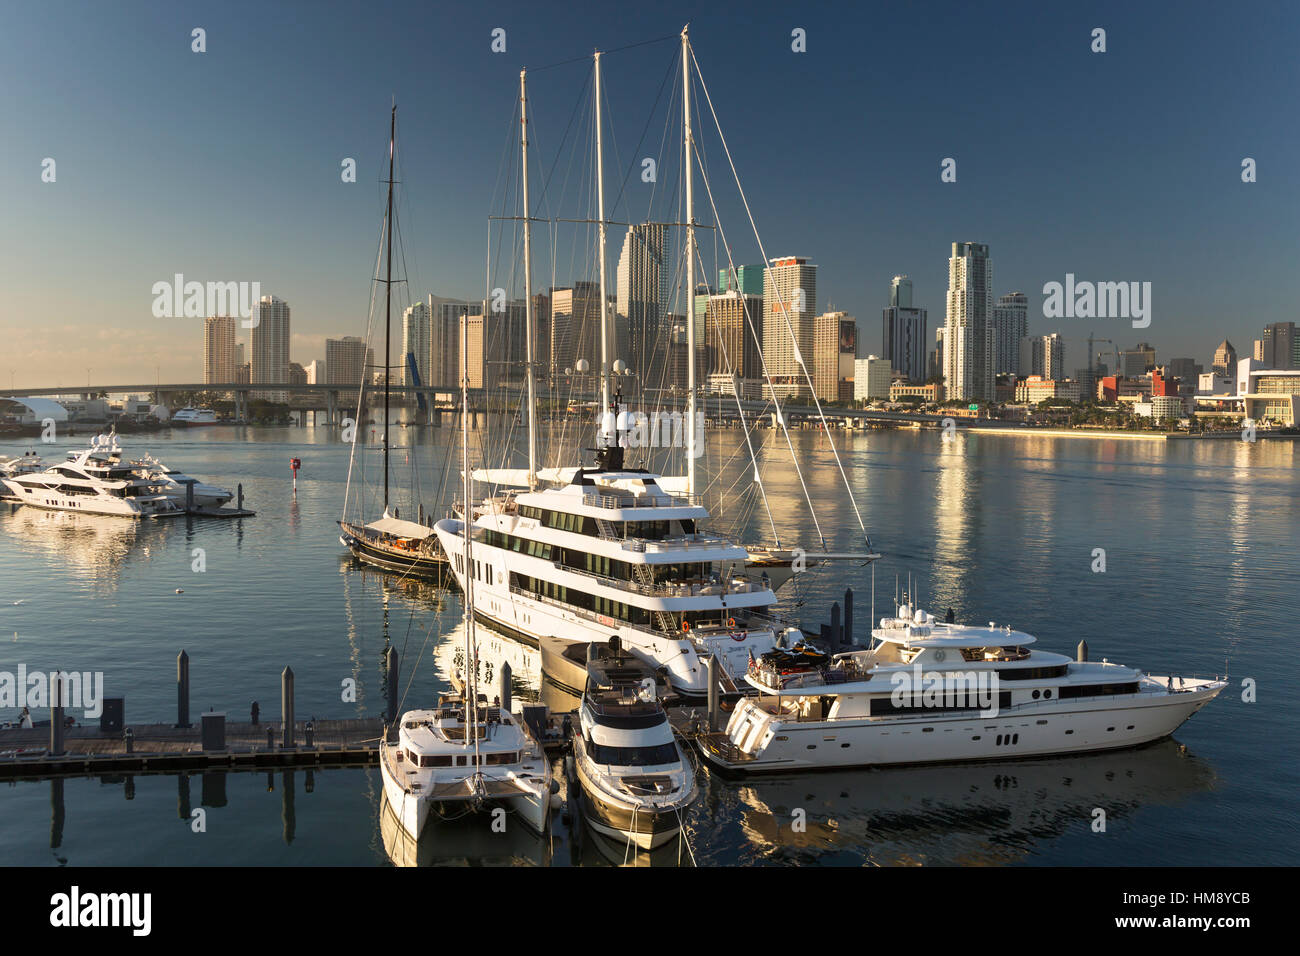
[763,256,818,398]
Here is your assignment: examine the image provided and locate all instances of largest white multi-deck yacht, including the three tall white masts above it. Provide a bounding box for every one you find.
[436,30,821,698]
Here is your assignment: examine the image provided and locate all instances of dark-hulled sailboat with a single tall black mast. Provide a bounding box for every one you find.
[338,105,447,580]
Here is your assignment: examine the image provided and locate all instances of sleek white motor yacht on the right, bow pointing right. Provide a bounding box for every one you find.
[699,604,1227,774]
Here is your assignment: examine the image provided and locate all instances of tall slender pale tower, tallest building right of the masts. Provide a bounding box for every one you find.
[944,242,995,401]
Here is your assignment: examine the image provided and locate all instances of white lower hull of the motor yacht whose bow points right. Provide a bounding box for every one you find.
[699,682,1226,774]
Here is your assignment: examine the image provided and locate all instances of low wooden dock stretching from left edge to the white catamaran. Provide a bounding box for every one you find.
[0,717,384,779]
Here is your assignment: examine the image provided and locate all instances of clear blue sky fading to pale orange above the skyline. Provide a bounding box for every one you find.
[0,1,1300,388]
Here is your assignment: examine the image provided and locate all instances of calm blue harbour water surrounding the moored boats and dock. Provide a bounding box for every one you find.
[0,428,1300,865]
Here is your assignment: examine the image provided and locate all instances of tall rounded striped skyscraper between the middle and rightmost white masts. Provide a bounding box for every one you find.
[616,222,670,388]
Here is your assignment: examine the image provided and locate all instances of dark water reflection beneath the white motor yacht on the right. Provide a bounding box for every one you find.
[733,740,1217,865]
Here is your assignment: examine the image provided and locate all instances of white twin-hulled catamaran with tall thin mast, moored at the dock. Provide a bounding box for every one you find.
[380,303,558,842]
